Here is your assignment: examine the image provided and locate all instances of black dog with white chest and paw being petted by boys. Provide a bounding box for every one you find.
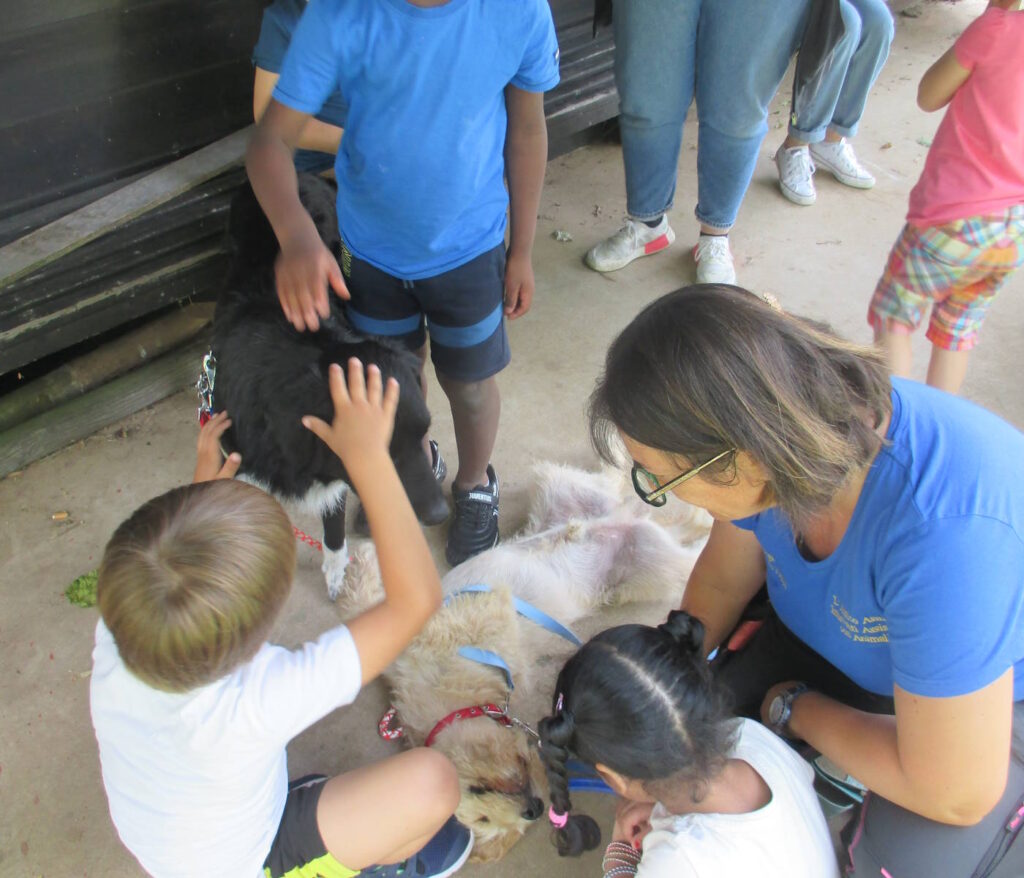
[213,174,447,599]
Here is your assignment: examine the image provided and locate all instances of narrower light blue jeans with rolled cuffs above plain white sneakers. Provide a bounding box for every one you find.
[790,0,894,143]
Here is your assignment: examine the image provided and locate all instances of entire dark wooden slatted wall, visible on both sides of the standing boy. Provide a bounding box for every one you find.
[0,0,617,373]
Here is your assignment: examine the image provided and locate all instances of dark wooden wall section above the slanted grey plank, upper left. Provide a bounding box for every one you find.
[0,0,263,240]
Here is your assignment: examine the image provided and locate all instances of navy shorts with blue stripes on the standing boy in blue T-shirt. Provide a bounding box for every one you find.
[341,243,512,382]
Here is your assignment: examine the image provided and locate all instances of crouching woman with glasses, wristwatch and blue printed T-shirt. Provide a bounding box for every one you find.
[591,285,1024,878]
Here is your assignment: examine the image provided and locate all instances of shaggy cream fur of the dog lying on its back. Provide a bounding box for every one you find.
[343,464,707,862]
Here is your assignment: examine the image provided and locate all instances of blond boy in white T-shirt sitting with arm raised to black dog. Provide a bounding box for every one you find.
[91,360,472,878]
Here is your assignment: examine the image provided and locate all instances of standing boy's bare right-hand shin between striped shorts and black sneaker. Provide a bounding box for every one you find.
[437,374,502,491]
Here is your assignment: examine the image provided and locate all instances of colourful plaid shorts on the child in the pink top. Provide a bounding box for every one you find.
[867,205,1024,350]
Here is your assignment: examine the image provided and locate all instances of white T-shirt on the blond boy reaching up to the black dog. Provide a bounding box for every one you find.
[90,621,362,878]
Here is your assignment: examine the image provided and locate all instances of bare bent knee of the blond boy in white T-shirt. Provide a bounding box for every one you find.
[316,747,460,870]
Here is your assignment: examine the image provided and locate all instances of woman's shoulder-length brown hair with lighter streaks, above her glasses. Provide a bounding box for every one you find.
[590,284,892,527]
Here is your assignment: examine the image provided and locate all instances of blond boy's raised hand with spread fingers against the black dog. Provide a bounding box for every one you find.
[302,357,398,473]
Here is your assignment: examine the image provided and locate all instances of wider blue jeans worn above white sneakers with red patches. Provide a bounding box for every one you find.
[613,0,809,229]
